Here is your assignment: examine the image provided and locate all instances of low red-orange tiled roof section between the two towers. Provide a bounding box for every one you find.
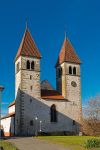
[41,90,66,100]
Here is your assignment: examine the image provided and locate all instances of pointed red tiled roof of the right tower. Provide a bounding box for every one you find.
[56,38,81,66]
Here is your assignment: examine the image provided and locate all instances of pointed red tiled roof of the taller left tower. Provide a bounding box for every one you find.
[15,29,41,61]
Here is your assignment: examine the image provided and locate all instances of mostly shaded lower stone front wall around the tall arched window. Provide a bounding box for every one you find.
[11,90,81,136]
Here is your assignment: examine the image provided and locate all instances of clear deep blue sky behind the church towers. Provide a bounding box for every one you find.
[0,0,100,113]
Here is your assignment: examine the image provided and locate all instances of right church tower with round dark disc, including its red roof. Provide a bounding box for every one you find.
[56,38,82,130]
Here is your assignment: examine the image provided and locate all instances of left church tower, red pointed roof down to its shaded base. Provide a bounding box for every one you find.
[15,28,41,135]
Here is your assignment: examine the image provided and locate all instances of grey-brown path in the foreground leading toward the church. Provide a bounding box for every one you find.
[8,137,69,150]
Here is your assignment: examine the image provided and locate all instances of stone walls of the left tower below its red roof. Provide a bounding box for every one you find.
[15,56,40,135]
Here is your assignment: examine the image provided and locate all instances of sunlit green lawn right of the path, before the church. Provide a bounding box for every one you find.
[39,136,100,150]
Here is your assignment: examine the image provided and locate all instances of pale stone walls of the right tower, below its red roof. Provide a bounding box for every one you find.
[56,62,82,130]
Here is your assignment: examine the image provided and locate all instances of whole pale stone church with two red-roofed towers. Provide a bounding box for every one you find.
[1,27,82,136]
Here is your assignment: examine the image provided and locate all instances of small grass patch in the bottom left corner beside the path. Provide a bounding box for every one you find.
[0,140,18,150]
